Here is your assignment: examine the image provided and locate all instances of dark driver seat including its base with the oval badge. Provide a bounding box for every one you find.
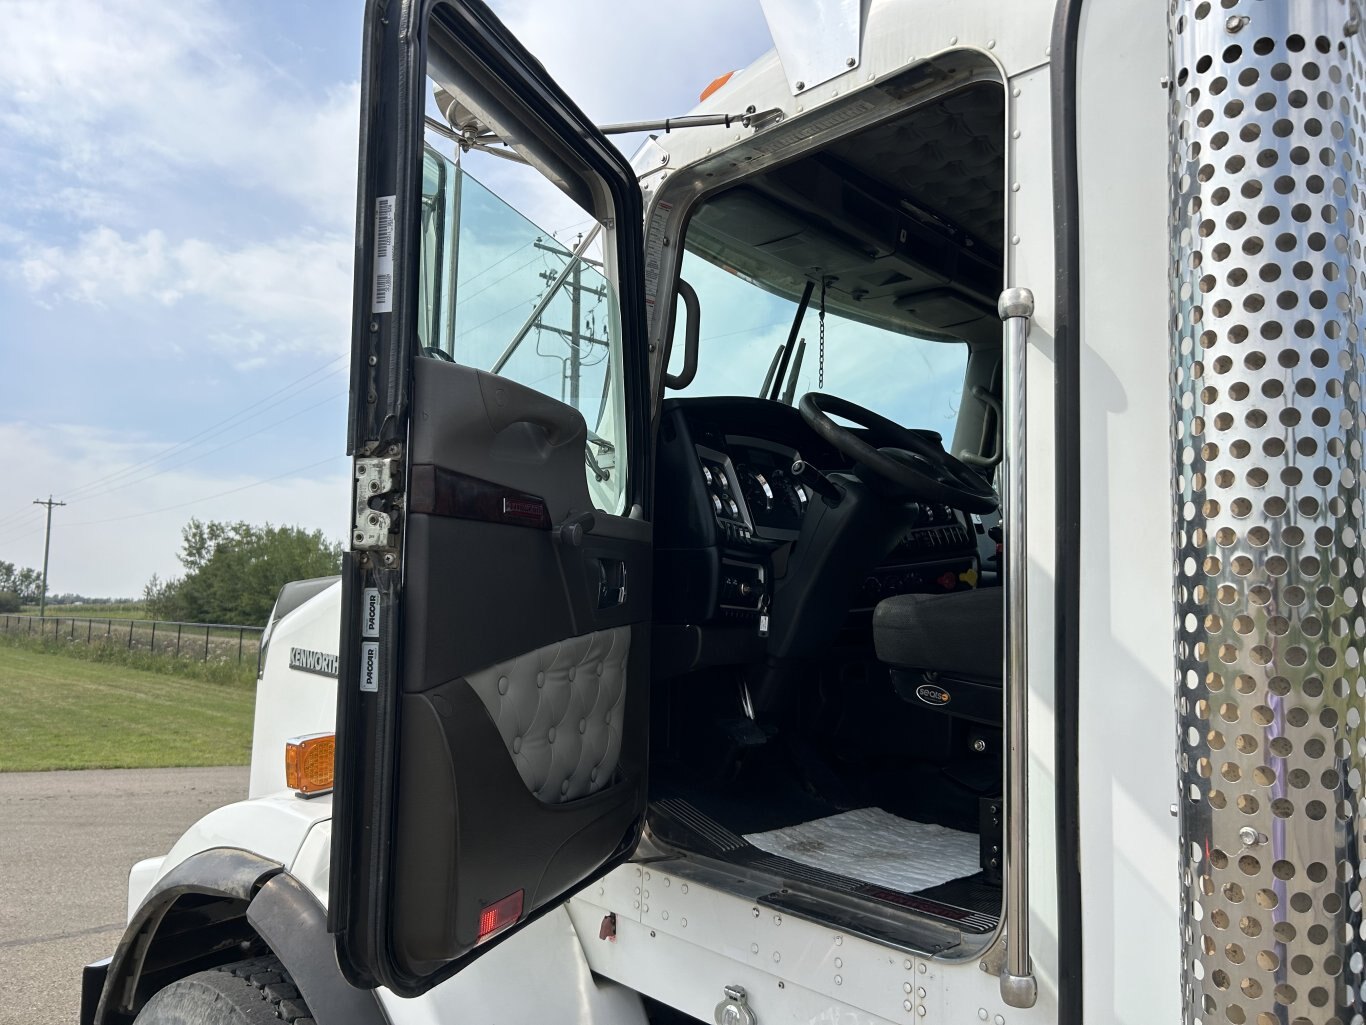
[873,588,1005,726]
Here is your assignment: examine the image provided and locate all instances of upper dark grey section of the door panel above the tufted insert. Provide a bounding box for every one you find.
[404,359,652,690]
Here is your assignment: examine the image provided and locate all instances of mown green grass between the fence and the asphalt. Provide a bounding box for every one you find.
[0,641,255,772]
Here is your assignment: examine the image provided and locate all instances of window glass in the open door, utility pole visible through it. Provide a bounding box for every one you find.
[418,138,626,513]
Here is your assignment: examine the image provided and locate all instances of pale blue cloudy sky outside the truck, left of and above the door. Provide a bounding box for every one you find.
[0,0,770,597]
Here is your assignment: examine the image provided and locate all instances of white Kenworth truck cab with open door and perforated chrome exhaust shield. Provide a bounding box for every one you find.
[82,0,1366,1025]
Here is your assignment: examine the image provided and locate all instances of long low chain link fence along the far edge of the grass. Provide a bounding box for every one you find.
[0,615,262,664]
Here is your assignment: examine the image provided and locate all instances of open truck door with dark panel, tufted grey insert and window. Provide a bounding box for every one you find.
[329,0,652,995]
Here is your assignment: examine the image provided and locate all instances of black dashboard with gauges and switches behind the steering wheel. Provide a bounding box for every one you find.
[654,396,986,639]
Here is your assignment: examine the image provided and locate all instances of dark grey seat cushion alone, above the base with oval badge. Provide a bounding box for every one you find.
[873,588,1005,681]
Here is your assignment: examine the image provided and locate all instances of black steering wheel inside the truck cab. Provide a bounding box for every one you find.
[798,391,997,513]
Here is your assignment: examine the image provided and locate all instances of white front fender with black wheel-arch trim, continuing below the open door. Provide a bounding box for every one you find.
[101,793,647,1025]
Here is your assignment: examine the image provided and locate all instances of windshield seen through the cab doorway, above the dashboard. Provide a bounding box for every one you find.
[669,251,967,439]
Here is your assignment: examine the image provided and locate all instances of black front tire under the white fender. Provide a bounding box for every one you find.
[135,957,314,1025]
